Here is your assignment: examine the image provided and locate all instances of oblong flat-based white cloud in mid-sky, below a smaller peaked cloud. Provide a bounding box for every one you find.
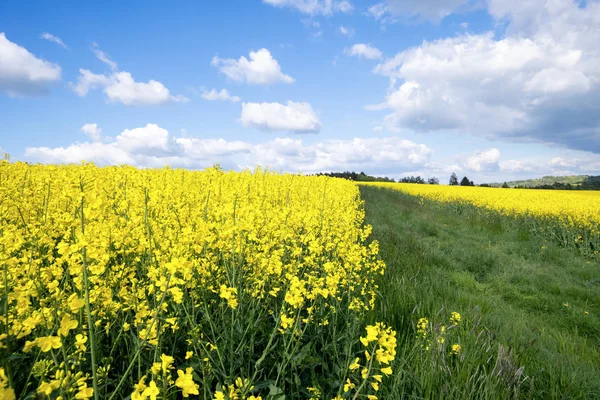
[241,101,321,133]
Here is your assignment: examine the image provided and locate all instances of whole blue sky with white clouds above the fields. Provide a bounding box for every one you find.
[0,0,600,182]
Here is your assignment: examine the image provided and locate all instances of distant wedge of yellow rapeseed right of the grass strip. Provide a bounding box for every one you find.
[361,182,600,254]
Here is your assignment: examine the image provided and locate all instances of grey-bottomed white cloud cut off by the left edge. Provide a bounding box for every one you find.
[0,32,61,96]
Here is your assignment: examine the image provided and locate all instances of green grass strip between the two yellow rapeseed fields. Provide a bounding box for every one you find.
[361,187,600,399]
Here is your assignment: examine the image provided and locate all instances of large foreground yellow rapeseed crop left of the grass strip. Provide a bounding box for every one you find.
[0,162,396,400]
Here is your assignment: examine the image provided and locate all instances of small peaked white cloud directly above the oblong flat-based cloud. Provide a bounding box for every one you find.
[211,49,294,85]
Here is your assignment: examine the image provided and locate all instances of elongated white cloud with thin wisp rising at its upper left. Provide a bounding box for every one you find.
[69,48,189,106]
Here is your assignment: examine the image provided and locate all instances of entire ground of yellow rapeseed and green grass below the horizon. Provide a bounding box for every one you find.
[0,161,600,400]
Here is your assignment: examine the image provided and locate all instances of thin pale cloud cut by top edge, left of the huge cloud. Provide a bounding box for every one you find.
[368,0,481,22]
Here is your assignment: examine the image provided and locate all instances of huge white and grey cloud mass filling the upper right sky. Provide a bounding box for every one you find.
[371,0,600,152]
